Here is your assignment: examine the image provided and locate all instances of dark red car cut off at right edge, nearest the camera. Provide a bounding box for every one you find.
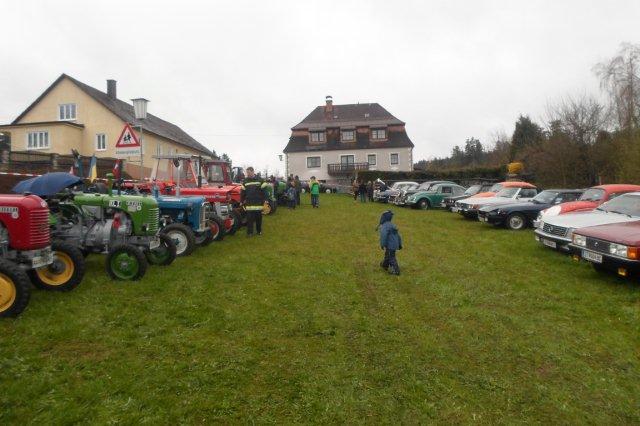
[569,221,640,277]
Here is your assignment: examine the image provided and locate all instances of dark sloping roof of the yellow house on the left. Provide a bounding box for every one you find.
[11,74,215,156]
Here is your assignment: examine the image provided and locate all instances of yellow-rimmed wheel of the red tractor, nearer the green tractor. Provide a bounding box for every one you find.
[29,241,85,291]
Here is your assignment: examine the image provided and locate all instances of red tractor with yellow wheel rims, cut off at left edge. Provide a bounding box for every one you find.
[0,195,85,317]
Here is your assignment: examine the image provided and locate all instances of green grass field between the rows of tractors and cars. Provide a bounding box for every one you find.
[0,195,640,424]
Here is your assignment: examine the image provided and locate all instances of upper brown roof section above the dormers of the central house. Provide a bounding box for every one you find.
[291,103,405,130]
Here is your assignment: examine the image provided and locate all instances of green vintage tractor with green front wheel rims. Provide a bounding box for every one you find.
[49,180,176,280]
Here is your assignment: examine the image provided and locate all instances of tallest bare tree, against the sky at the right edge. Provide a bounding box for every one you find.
[593,43,640,130]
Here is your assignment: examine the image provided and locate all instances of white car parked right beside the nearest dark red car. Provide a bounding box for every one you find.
[535,192,640,253]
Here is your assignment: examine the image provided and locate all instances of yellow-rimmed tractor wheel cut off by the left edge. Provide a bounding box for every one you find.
[0,259,31,318]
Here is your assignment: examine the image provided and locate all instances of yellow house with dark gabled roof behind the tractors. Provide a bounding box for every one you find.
[0,74,214,178]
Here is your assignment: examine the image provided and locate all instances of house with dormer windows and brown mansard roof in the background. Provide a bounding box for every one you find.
[284,96,413,184]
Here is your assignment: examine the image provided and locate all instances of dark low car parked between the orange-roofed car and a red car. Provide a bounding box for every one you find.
[478,189,584,231]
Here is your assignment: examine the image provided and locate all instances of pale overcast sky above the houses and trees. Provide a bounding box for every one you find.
[0,0,640,173]
